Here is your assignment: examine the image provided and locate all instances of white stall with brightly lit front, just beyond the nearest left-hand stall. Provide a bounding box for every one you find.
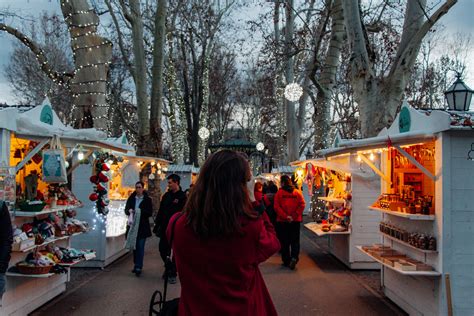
[72,140,169,268]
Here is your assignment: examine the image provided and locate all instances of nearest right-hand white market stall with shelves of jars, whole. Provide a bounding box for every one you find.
[327,104,474,315]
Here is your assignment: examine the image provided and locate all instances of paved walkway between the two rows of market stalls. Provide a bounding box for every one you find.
[32,232,405,316]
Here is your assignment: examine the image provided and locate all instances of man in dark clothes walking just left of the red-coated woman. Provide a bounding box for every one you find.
[153,174,186,284]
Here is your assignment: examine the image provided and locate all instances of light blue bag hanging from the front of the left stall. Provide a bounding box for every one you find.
[42,135,67,183]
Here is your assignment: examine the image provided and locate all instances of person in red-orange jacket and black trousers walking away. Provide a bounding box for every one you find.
[274,175,305,270]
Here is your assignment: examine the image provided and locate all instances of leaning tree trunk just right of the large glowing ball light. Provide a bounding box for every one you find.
[313,0,344,151]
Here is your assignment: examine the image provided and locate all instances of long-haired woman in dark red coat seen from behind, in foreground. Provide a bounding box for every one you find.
[167,150,280,316]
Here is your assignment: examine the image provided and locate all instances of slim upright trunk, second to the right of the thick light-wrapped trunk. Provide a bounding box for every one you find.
[150,0,167,156]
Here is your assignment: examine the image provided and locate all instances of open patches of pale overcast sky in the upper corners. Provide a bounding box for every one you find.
[0,0,474,104]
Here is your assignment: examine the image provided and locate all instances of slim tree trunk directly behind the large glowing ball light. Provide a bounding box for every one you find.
[285,0,300,163]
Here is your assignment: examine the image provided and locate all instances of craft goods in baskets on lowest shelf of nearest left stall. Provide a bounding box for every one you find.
[9,244,94,274]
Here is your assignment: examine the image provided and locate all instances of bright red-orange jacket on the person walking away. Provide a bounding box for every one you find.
[273,189,305,222]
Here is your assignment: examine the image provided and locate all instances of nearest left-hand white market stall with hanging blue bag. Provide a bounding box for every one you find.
[0,100,128,315]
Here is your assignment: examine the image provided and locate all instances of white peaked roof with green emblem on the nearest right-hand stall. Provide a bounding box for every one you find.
[316,102,474,157]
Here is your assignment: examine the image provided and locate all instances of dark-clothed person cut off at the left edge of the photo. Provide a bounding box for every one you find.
[0,200,13,305]
